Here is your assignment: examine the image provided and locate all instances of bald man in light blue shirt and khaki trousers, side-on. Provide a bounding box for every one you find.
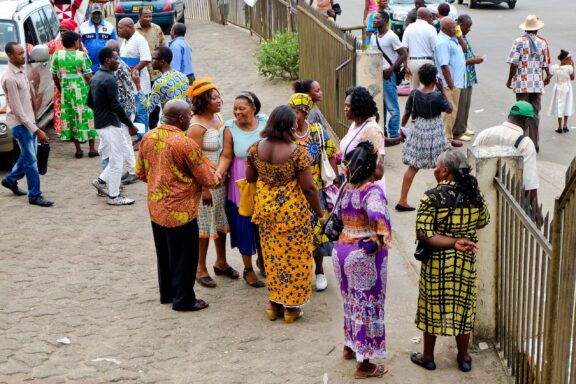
[434,17,470,147]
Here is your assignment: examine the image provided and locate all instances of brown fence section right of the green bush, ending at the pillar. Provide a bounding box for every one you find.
[298,2,357,137]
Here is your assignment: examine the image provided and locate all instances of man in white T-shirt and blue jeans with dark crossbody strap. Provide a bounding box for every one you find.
[370,11,407,138]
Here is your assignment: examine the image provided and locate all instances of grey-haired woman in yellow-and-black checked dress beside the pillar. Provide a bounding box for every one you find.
[410,149,490,372]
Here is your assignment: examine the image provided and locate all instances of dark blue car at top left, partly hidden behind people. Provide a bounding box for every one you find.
[114,0,185,34]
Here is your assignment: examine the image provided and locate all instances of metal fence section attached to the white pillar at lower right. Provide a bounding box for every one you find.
[494,167,551,383]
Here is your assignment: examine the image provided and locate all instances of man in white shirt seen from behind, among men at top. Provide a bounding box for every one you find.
[402,7,436,89]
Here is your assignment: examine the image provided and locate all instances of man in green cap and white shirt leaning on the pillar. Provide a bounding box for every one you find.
[473,101,542,225]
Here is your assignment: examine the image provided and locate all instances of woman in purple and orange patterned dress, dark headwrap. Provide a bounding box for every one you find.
[332,141,392,379]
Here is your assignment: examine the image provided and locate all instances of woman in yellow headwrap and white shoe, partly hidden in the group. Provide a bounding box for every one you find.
[288,93,340,291]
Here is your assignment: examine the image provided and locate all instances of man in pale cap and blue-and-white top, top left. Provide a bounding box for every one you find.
[80,3,118,73]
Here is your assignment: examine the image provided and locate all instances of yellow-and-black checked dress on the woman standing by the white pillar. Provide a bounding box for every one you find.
[415,181,490,336]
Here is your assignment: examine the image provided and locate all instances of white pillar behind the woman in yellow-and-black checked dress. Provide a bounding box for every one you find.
[468,146,523,340]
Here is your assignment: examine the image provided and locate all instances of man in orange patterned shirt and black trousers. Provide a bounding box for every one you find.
[136,100,220,311]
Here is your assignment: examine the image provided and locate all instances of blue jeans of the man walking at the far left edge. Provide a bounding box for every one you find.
[6,125,42,197]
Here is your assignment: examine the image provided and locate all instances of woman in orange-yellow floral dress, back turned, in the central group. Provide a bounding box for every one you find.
[246,105,323,323]
